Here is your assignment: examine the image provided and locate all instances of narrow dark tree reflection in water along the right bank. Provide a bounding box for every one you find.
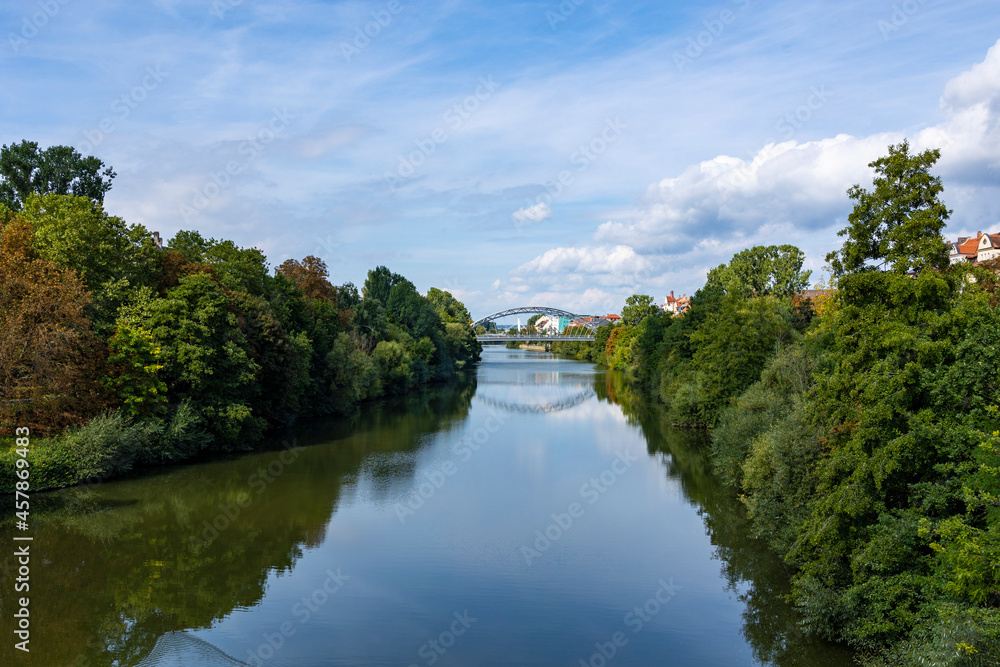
[594,372,852,667]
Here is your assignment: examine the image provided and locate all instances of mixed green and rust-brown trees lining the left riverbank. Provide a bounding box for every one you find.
[0,141,482,490]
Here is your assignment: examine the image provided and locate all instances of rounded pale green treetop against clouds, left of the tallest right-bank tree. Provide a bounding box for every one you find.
[708,245,812,298]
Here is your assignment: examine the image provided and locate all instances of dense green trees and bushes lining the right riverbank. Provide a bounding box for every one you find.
[553,142,1000,667]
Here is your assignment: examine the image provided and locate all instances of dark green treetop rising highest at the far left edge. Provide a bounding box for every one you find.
[0,141,116,211]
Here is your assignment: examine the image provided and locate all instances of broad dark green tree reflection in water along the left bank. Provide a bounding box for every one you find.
[0,380,475,666]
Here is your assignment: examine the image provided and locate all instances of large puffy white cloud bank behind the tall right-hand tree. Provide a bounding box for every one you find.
[511,41,1000,314]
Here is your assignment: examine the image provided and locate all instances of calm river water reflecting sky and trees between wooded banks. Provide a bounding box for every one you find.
[0,347,851,667]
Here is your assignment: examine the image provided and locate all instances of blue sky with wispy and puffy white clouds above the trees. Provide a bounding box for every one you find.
[0,0,1000,317]
